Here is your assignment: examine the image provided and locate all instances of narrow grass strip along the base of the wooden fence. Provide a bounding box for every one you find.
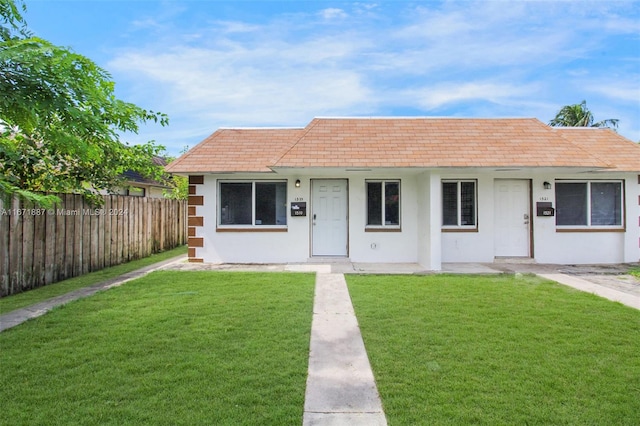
[0,246,187,314]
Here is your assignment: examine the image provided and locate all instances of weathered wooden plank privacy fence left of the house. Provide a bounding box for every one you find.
[0,194,187,296]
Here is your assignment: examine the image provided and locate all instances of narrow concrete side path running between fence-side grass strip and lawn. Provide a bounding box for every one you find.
[0,255,187,332]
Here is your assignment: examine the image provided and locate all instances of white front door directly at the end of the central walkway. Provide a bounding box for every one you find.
[311,179,348,256]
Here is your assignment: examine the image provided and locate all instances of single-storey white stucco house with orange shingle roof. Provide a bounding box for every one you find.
[167,118,640,270]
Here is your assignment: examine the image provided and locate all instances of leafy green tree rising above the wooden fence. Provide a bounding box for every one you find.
[0,0,168,205]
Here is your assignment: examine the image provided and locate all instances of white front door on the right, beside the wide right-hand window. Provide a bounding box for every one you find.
[494,179,531,257]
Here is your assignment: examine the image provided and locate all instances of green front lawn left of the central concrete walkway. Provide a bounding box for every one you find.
[0,271,315,425]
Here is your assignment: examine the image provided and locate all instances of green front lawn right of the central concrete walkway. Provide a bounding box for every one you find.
[347,275,640,425]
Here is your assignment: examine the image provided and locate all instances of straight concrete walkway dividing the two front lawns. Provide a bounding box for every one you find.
[303,272,387,426]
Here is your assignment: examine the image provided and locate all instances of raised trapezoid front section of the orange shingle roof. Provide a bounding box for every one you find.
[275,118,606,167]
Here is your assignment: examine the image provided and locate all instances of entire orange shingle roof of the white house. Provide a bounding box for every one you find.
[167,118,640,173]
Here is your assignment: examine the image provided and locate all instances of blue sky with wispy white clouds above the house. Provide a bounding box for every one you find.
[25,0,640,155]
